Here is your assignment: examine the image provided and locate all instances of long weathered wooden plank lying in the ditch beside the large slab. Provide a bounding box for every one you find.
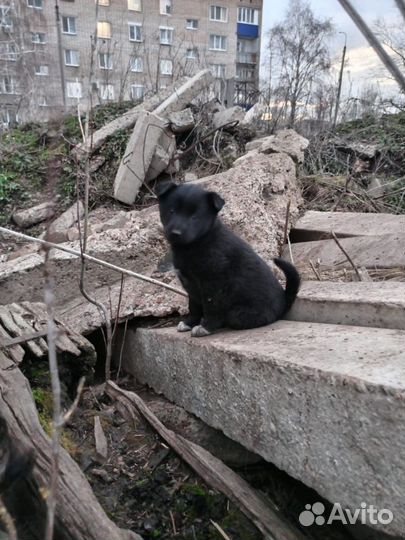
[106,381,304,540]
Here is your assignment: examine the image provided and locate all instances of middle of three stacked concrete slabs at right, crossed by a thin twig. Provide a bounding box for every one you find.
[282,232,405,270]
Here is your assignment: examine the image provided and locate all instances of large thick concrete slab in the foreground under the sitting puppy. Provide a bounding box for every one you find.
[124,321,405,535]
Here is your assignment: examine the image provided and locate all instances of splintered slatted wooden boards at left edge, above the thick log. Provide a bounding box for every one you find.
[0,302,95,364]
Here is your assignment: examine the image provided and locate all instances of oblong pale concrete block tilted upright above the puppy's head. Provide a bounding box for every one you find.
[114,112,170,204]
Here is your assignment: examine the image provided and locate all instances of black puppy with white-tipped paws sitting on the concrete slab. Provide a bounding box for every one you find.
[157,182,300,337]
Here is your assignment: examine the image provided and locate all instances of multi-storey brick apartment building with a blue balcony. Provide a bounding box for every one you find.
[0,0,262,126]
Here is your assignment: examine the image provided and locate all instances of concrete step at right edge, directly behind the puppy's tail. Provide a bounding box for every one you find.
[287,281,405,330]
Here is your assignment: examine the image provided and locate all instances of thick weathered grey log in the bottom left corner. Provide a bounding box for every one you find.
[0,351,142,540]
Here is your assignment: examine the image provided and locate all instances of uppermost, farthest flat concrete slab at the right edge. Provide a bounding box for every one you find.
[290,211,405,242]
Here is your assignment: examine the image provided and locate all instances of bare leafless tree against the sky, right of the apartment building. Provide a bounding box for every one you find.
[268,0,333,126]
